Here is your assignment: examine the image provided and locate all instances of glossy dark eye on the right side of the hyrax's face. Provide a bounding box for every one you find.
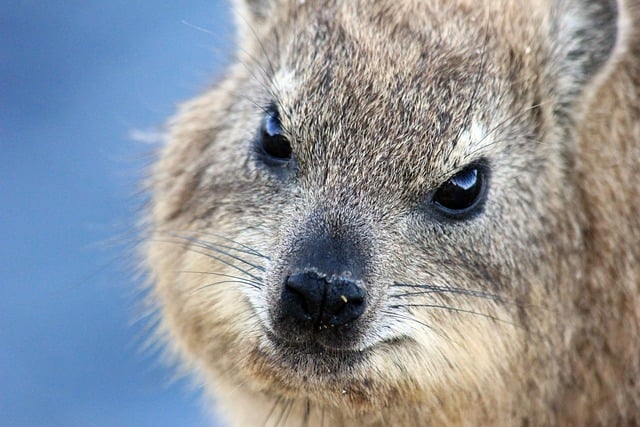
[431,164,487,219]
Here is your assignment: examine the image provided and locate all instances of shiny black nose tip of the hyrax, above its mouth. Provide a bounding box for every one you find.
[282,271,365,329]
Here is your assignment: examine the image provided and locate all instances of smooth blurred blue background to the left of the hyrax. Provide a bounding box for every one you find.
[0,0,234,427]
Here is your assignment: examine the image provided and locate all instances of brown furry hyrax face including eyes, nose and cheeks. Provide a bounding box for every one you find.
[149,1,615,422]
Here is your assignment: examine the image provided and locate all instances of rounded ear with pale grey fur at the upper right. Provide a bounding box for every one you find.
[549,0,618,103]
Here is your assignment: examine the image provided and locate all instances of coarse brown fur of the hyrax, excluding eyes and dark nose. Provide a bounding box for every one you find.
[145,0,640,426]
